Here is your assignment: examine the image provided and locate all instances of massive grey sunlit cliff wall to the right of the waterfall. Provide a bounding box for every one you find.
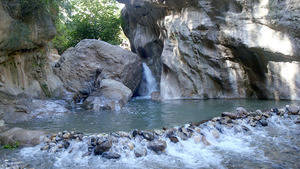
[120,0,300,100]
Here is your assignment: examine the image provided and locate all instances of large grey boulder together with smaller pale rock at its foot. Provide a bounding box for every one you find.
[54,39,142,110]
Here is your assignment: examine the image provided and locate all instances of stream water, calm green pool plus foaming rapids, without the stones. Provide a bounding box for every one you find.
[0,99,300,169]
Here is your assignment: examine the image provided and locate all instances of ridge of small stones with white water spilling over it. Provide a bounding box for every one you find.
[2,103,300,168]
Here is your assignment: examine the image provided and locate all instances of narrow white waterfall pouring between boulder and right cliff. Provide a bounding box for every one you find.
[138,63,158,98]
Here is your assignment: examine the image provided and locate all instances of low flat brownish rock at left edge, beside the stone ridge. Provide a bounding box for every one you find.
[0,127,47,146]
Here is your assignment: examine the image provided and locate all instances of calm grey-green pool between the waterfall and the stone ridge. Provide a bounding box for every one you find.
[9,99,300,133]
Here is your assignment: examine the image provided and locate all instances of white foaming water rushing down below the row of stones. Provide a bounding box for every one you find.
[14,115,300,169]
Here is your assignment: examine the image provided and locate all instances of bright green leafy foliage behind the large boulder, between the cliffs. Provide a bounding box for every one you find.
[53,0,121,53]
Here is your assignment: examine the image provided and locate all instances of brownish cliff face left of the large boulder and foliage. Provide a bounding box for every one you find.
[0,0,62,99]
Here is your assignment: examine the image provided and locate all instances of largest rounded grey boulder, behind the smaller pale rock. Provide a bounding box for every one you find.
[54,39,142,100]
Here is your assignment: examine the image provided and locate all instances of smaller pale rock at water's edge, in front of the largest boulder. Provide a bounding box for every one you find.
[84,79,132,111]
